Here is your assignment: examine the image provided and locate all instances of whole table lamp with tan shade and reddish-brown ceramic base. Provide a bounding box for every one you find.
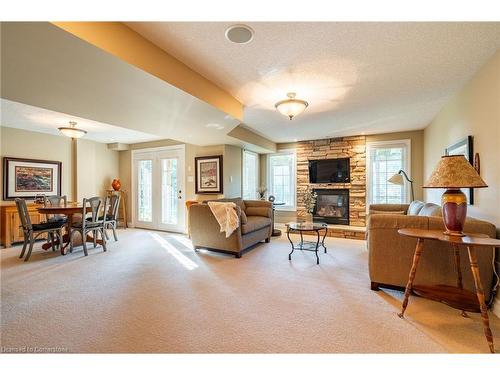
[423,155,488,236]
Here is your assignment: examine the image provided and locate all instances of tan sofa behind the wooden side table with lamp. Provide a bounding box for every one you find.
[367,201,496,299]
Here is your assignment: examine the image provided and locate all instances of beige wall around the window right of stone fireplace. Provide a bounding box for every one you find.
[366,130,424,200]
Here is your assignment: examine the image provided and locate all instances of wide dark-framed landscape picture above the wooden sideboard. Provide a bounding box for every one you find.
[3,157,62,201]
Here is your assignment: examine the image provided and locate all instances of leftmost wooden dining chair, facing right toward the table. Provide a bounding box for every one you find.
[16,198,65,262]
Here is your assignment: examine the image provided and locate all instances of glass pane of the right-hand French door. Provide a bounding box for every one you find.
[161,159,178,225]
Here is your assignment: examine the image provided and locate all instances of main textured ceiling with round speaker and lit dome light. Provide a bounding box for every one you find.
[127,22,500,142]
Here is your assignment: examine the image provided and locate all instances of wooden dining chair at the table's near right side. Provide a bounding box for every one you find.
[69,197,106,256]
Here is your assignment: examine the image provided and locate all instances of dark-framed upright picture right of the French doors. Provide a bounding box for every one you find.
[194,155,224,194]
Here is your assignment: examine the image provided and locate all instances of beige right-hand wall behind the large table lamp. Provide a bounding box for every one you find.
[424,51,500,316]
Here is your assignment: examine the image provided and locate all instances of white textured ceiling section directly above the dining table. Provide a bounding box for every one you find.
[0,99,160,143]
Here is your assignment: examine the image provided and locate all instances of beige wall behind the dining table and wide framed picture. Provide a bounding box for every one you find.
[1,127,119,203]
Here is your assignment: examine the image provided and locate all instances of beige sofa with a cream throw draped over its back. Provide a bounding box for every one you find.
[189,198,273,258]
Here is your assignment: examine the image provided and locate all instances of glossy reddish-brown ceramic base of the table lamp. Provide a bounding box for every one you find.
[441,189,467,236]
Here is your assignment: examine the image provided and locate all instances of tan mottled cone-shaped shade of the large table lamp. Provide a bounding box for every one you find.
[423,155,488,189]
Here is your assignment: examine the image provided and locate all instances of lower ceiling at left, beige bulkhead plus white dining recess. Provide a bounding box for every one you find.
[1,22,246,146]
